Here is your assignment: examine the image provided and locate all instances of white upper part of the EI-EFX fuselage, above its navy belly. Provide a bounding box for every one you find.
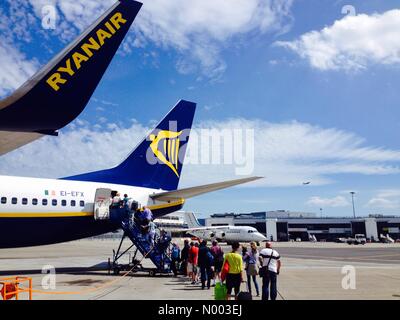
[0,176,162,217]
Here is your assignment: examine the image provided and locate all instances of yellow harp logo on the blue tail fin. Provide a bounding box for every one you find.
[150,130,182,178]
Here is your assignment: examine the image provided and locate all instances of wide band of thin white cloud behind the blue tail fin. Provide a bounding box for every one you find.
[0,119,400,188]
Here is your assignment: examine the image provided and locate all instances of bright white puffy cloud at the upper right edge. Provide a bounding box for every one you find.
[275,9,400,71]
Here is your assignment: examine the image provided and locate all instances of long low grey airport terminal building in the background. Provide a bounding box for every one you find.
[205,210,400,241]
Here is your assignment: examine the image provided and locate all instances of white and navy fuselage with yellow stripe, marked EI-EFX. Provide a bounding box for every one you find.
[0,176,184,248]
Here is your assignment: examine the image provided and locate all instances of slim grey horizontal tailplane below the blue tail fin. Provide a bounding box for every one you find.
[150,177,262,201]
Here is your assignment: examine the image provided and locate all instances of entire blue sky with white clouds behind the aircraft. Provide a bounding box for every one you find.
[0,0,400,216]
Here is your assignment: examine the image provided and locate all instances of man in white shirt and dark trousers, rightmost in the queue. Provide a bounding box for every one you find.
[259,242,281,300]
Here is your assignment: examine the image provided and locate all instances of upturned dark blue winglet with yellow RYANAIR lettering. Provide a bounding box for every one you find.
[0,0,142,155]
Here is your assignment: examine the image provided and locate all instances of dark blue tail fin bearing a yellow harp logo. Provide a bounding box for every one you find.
[63,100,196,190]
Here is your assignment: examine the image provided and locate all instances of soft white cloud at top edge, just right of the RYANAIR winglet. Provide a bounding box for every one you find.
[135,0,293,78]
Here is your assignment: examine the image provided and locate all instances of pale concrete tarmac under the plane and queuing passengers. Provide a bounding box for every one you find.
[0,239,400,300]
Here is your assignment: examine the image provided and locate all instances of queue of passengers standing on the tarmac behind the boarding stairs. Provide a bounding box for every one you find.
[171,240,282,300]
